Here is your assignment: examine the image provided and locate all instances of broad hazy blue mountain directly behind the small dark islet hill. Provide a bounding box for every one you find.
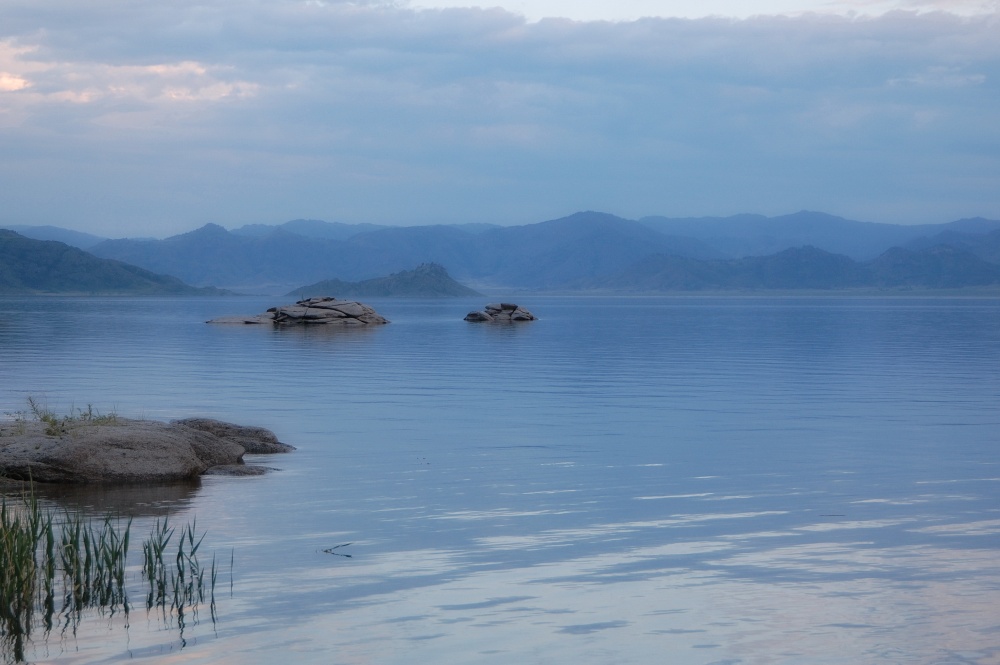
[93,212,719,293]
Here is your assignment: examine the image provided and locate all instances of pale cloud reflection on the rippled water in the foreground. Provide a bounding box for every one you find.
[189,542,996,665]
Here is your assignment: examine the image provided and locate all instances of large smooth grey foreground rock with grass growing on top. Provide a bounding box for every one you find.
[0,418,294,484]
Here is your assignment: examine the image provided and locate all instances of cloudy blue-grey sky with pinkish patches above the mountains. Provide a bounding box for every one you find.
[0,0,1000,237]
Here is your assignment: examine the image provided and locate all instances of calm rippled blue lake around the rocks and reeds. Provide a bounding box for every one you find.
[0,297,1000,665]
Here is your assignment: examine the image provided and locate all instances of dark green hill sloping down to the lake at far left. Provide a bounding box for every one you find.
[0,230,221,295]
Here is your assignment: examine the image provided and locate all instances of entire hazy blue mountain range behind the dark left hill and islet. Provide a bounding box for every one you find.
[5,211,1000,294]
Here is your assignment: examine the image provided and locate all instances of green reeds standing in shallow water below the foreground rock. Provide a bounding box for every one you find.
[0,494,218,662]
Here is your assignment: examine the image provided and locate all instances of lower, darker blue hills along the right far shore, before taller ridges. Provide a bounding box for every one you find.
[578,245,1000,293]
